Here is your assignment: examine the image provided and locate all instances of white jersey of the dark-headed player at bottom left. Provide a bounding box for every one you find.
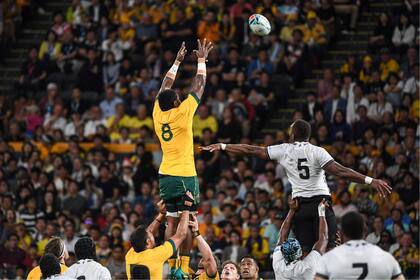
[64,259,112,280]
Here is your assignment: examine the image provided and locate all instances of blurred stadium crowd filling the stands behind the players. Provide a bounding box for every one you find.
[0,0,420,279]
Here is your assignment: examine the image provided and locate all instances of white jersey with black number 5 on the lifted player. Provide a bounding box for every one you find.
[267,142,334,198]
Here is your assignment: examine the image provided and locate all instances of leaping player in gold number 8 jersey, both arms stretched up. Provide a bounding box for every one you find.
[153,39,213,278]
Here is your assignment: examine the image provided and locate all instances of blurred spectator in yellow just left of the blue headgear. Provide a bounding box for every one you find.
[244,225,270,267]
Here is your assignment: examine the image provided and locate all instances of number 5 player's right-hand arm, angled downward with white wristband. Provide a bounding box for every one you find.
[323,161,392,197]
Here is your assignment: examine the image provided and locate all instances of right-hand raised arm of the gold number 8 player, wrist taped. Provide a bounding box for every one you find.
[190,39,213,99]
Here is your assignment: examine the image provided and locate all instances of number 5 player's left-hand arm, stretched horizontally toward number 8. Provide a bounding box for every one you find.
[201,143,270,159]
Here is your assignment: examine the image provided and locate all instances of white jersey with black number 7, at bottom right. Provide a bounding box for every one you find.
[316,240,401,280]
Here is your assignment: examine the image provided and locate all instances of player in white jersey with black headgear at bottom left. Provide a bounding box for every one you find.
[64,237,112,280]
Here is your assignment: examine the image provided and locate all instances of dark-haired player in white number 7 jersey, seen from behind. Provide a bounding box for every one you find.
[315,212,404,280]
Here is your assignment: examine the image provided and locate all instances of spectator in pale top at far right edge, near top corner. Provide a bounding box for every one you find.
[392,14,416,53]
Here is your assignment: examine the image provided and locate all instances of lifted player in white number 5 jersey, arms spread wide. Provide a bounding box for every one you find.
[202,120,391,252]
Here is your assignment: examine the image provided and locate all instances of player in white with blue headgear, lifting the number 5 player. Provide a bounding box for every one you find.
[273,199,329,280]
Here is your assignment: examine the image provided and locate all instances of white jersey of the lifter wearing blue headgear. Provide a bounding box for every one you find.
[273,246,321,280]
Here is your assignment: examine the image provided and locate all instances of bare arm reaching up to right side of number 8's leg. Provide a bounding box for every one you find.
[189,215,217,278]
